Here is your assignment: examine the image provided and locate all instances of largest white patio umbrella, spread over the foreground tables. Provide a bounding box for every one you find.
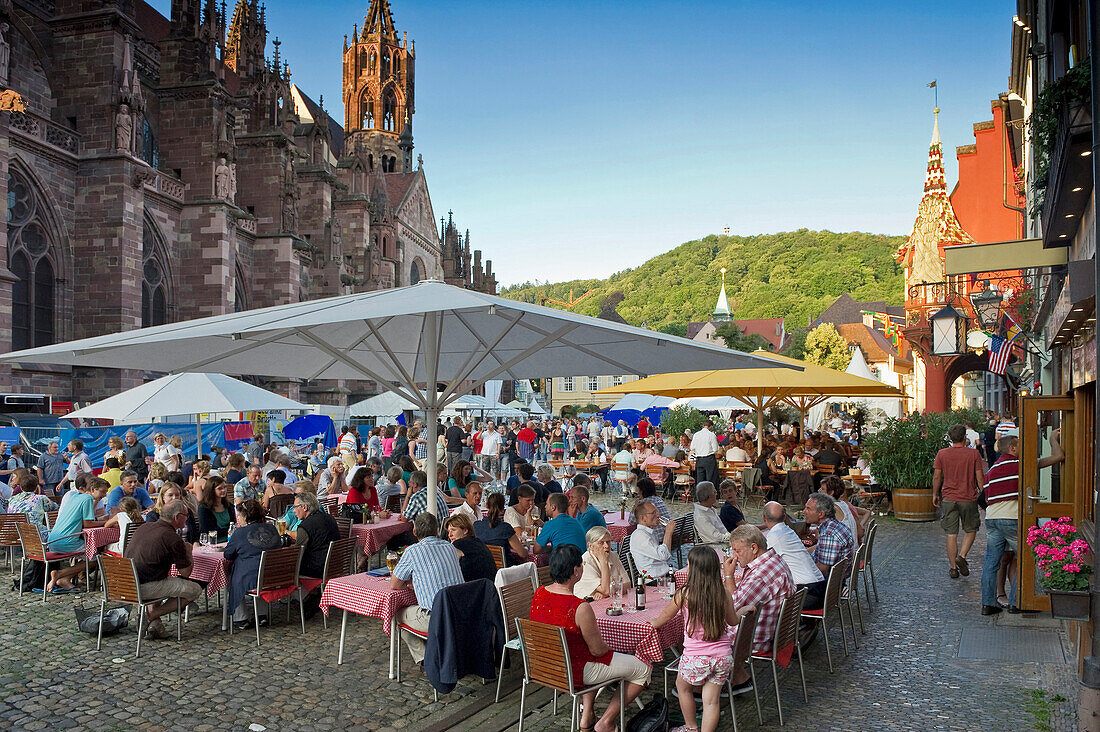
[0,280,798,512]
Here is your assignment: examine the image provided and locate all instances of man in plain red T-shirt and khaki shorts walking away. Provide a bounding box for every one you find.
[932,425,986,579]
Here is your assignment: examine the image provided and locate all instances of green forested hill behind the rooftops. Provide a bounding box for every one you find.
[501,229,904,335]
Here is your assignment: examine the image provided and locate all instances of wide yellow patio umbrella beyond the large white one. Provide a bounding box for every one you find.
[596,350,905,448]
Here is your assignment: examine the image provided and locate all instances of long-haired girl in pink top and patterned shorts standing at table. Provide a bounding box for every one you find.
[653,546,740,732]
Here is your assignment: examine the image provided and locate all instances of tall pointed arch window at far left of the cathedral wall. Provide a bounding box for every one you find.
[8,171,56,350]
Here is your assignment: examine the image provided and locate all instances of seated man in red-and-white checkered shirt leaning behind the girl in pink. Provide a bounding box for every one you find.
[722,524,794,687]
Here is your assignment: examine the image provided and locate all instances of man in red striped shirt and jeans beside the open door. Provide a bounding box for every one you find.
[981,429,1066,615]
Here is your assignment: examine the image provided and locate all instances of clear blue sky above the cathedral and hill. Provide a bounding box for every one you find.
[154,0,1015,284]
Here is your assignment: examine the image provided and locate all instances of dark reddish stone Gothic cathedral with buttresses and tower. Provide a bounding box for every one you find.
[0,0,496,404]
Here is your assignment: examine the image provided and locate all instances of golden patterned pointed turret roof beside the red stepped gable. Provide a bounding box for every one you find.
[897,107,974,291]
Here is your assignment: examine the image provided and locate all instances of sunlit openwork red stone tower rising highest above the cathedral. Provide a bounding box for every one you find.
[343,0,416,173]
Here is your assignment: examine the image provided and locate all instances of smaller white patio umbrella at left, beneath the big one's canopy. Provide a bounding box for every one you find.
[65,373,309,455]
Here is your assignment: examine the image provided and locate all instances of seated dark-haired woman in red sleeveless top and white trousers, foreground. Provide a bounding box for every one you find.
[531,544,650,732]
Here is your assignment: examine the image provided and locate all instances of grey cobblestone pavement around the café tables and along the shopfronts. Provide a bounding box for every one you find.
[0,495,1077,732]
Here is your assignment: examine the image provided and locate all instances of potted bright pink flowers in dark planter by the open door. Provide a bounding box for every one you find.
[1027,516,1092,620]
